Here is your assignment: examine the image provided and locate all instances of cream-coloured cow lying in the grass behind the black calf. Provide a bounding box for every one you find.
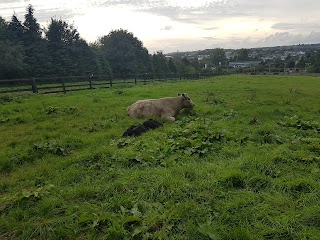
[127,93,195,121]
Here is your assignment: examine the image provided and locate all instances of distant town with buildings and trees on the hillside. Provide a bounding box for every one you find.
[166,43,320,72]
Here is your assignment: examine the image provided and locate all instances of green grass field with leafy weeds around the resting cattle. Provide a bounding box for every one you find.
[0,75,320,240]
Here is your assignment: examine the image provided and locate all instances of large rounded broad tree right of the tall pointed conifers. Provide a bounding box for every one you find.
[99,29,152,74]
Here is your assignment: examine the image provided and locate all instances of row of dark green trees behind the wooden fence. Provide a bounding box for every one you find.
[0,5,205,79]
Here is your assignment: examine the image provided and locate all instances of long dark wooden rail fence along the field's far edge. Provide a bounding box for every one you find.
[0,73,214,94]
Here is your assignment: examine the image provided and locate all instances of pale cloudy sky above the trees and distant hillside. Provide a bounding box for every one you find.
[0,0,320,54]
